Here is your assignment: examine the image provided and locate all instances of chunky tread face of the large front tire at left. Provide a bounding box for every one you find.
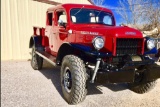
[62,55,87,104]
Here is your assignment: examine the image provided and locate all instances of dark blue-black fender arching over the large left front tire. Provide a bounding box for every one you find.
[56,43,112,64]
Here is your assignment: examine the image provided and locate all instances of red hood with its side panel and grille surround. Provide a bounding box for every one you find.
[70,25,144,56]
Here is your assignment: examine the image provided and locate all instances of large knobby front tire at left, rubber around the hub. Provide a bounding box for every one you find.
[61,55,87,105]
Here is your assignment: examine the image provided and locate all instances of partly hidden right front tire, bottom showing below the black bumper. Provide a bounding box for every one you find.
[129,81,156,94]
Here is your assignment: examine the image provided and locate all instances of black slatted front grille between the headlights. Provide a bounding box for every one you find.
[116,38,142,56]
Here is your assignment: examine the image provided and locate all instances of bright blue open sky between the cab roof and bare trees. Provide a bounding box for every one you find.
[92,0,160,26]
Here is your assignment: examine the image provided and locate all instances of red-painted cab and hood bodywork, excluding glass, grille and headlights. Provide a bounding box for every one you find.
[34,4,144,56]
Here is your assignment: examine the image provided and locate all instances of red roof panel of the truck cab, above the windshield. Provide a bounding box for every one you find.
[47,3,112,13]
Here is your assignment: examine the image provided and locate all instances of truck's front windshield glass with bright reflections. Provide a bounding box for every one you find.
[70,8,114,26]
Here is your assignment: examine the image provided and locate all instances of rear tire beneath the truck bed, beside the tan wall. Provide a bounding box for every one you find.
[31,46,43,70]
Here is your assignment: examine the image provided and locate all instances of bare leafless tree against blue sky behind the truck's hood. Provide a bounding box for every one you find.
[117,0,160,30]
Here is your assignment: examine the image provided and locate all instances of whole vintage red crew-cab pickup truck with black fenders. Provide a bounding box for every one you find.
[29,4,160,104]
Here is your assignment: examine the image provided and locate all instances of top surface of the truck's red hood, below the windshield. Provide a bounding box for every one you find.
[75,25,143,38]
